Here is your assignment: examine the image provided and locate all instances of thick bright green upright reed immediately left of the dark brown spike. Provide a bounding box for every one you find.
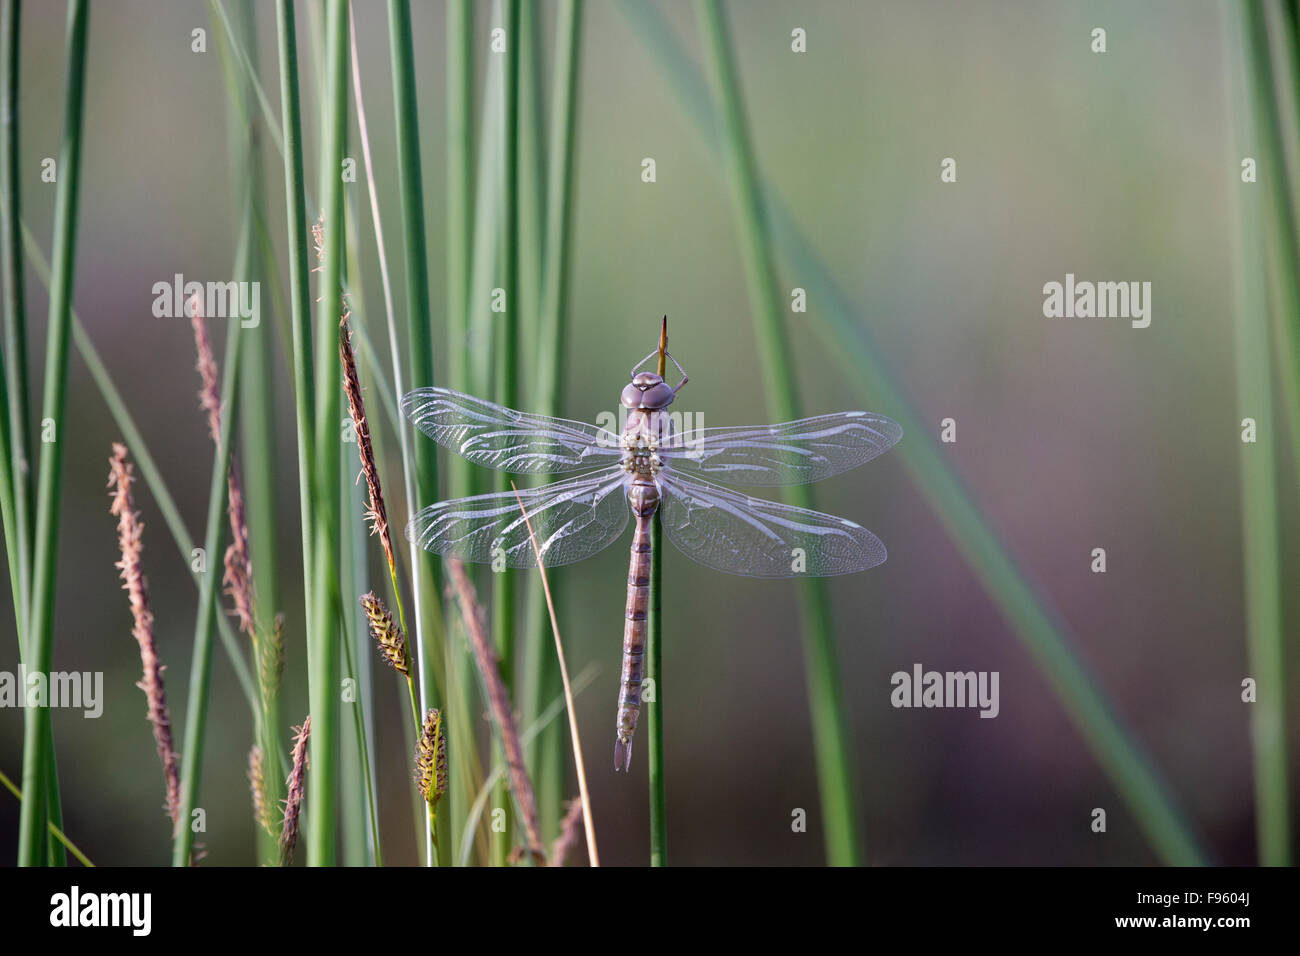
[307,0,348,866]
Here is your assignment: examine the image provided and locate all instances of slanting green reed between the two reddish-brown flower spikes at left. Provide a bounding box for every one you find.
[172,321,243,866]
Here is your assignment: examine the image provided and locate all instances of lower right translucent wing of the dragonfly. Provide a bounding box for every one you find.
[659,472,887,578]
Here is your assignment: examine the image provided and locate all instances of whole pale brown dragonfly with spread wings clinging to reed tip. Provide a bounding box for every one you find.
[402,317,902,771]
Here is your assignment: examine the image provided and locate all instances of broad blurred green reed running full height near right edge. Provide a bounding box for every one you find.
[1225,4,1300,866]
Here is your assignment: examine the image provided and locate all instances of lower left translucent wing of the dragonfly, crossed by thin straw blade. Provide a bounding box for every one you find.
[407,467,631,567]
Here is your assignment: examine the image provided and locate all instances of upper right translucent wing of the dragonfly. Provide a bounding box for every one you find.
[659,411,902,485]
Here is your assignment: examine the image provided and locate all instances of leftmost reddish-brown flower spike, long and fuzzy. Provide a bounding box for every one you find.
[108,442,181,825]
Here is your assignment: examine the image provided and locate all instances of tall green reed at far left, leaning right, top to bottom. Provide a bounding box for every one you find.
[18,0,88,866]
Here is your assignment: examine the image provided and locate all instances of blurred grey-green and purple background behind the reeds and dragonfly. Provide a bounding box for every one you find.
[0,0,1300,865]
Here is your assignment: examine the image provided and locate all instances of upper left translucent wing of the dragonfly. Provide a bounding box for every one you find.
[402,388,623,475]
